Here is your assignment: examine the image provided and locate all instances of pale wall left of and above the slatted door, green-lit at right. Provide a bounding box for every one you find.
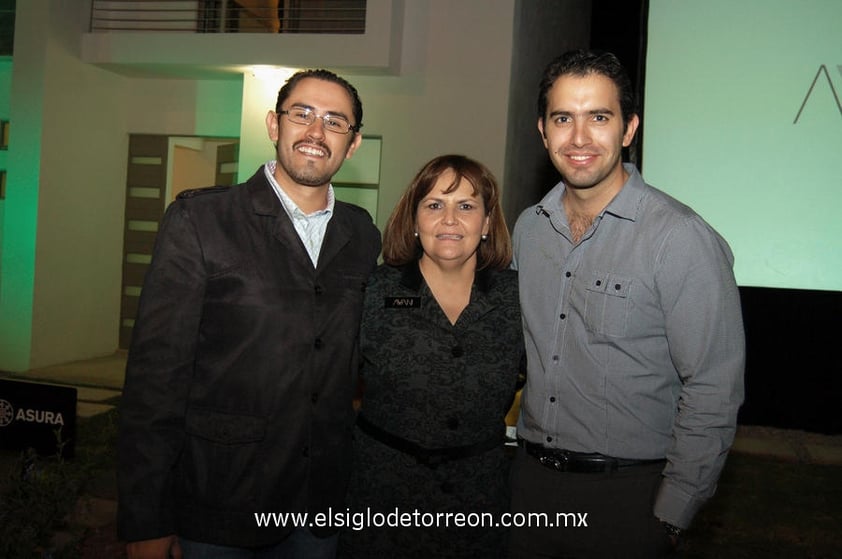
[19,4,241,368]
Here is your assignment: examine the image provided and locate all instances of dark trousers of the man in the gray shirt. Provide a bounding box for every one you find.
[509,448,674,559]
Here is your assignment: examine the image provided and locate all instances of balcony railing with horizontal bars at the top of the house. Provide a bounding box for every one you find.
[90,0,366,34]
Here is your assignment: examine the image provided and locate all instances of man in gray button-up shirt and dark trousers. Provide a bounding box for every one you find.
[511,51,745,558]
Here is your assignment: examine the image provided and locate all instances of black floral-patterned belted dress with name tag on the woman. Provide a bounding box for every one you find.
[340,263,523,559]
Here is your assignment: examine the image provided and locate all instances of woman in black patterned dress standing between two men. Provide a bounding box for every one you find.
[342,155,523,559]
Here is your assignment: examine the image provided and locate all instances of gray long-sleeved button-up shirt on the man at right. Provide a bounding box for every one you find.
[513,165,745,527]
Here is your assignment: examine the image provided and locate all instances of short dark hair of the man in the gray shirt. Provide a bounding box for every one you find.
[538,50,637,128]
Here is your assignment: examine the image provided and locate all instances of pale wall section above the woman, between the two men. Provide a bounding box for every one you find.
[351,0,514,230]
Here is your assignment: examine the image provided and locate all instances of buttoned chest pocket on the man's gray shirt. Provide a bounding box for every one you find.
[585,271,633,337]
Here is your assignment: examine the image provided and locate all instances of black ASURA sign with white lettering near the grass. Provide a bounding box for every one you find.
[0,379,76,458]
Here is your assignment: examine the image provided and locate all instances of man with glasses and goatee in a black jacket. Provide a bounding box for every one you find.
[118,70,380,559]
